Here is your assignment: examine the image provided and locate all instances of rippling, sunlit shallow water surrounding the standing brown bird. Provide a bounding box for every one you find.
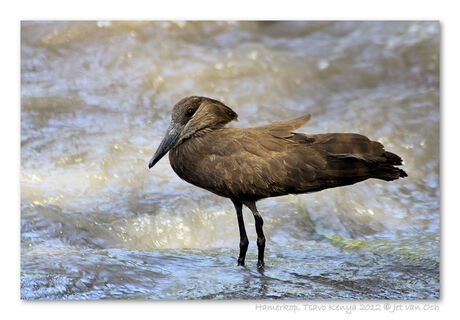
[21,21,440,299]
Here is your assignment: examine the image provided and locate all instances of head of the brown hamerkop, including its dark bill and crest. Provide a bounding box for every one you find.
[149,96,238,168]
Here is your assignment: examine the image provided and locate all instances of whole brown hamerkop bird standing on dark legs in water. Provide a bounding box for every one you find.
[149,96,407,268]
